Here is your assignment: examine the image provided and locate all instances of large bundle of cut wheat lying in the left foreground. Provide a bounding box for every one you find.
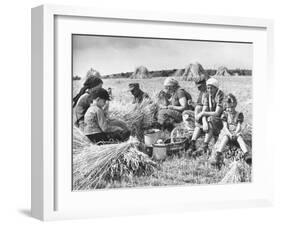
[73,138,157,190]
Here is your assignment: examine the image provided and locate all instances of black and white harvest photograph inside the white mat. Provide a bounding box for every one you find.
[70,34,252,191]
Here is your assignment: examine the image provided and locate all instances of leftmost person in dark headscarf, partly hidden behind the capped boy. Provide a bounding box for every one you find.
[73,75,103,131]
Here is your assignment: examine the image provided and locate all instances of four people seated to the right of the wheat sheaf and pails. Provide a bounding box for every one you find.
[155,76,252,166]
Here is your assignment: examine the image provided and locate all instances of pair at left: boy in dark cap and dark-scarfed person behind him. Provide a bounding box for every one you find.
[73,76,130,145]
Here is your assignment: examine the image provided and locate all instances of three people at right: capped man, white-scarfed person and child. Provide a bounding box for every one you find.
[187,78,252,166]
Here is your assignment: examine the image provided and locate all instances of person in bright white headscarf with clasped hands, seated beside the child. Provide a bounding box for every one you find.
[188,78,224,157]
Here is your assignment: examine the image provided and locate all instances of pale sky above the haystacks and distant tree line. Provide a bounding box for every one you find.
[72,35,253,77]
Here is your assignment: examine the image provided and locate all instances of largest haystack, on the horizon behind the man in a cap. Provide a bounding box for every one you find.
[182,62,208,81]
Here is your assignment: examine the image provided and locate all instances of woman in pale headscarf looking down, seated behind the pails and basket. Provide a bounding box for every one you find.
[158,77,194,129]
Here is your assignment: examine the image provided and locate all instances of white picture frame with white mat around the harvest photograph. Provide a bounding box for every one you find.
[31,5,274,220]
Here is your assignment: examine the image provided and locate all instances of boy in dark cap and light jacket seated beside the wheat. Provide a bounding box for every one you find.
[84,88,130,143]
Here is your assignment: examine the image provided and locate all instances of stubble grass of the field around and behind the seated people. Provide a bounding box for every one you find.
[73,76,252,188]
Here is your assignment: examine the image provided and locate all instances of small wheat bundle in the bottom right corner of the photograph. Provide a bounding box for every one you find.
[220,161,251,184]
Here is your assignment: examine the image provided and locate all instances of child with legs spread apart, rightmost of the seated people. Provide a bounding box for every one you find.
[211,94,252,168]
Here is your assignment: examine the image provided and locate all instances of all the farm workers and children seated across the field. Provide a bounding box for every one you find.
[73,72,251,168]
